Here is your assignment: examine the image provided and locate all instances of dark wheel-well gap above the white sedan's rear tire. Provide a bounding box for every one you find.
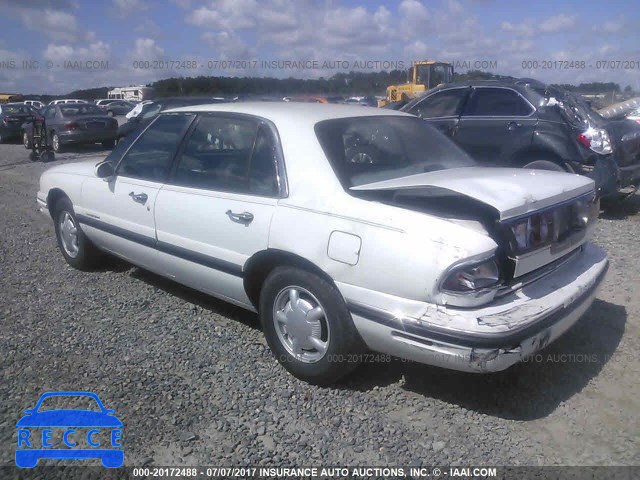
[243,248,335,310]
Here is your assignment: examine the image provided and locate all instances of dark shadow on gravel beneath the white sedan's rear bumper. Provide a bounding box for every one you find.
[338,300,627,421]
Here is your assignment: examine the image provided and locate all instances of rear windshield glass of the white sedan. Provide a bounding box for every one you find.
[315,116,475,189]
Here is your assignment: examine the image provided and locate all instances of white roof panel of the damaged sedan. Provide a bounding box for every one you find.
[165,102,408,124]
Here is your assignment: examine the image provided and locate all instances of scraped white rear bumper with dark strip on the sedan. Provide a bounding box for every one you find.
[338,244,608,372]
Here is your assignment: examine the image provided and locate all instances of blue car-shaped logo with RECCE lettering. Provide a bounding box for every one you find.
[16,391,124,468]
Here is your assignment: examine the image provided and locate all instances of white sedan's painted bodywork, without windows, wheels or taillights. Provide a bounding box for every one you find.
[38,102,607,371]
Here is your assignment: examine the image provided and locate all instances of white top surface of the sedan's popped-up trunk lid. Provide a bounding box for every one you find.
[351,167,594,220]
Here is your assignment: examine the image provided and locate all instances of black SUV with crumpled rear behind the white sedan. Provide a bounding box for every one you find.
[401,79,640,198]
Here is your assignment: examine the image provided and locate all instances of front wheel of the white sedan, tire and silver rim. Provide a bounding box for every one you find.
[53,198,100,270]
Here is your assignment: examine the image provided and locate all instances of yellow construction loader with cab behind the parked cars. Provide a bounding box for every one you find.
[378,60,453,107]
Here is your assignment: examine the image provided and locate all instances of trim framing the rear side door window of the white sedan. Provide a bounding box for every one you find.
[166,111,289,199]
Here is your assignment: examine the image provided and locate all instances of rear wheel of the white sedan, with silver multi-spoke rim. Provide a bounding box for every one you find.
[260,267,365,385]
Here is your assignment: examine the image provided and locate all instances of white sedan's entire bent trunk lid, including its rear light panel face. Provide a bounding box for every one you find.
[351,167,599,282]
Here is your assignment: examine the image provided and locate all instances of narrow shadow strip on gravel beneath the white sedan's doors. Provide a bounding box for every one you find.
[130,268,262,330]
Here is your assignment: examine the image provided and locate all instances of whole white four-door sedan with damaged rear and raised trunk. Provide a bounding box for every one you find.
[37,102,608,384]
